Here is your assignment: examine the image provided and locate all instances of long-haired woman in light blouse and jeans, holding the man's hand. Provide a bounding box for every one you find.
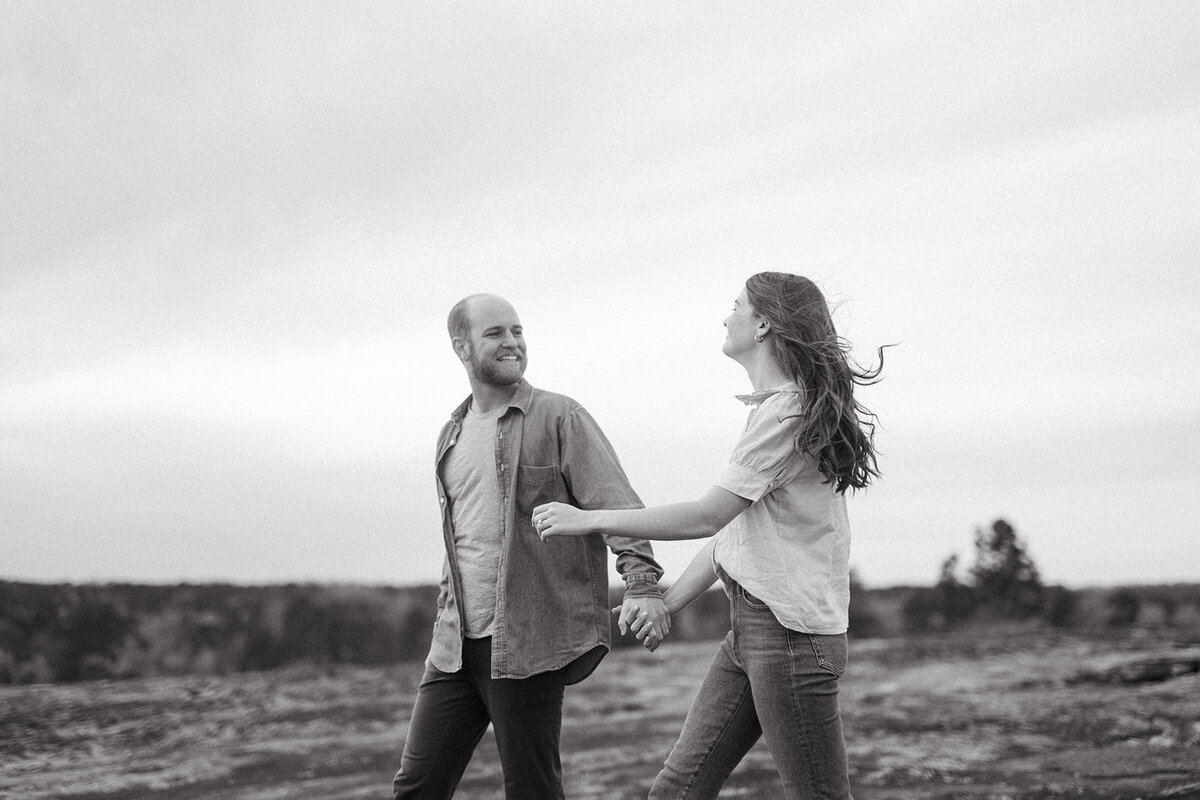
[533,272,882,800]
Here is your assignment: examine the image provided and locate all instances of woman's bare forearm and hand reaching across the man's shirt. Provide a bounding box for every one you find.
[533,486,750,542]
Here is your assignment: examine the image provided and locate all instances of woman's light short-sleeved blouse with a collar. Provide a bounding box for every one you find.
[713,384,850,633]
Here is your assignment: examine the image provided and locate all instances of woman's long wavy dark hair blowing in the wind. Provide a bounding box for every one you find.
[746,272,883,492]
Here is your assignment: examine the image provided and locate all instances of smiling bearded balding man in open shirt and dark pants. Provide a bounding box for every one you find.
[392,295,670,800]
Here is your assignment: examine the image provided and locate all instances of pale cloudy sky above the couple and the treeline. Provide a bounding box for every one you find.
[0,0,1200,587]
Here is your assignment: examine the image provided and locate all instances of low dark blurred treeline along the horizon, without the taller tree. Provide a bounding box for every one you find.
[7,582,1200,684]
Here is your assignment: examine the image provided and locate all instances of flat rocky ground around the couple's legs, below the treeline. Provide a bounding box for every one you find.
[0,631,1200,800]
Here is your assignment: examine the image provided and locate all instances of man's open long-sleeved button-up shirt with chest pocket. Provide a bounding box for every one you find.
[427,380,662,682]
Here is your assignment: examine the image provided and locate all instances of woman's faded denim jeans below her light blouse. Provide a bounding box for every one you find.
[649,583,850,800]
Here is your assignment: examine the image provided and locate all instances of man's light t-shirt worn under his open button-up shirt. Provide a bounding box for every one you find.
[443,405,508,639]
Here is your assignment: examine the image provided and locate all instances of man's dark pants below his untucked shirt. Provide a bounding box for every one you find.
[392,638,565,800]
